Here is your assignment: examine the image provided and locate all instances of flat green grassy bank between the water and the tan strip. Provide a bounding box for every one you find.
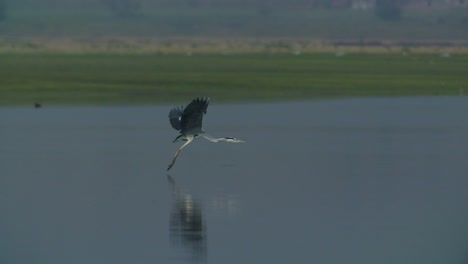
[0,53,468,105]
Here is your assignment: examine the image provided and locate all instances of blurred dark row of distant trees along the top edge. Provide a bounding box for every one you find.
[0,0,468,21]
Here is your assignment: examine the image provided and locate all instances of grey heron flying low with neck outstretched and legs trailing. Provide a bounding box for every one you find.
[167,98,244,171]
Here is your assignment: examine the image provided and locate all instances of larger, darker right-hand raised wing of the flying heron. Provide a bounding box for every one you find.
[180,98,210,134]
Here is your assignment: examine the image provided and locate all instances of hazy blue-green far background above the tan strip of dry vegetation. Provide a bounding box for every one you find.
[0,0,468,42]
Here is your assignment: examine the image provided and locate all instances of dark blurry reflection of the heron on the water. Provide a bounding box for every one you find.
[167,175,207,262]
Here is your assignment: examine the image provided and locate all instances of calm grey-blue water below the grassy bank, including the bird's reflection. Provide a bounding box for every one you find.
[0,97,468,264]
